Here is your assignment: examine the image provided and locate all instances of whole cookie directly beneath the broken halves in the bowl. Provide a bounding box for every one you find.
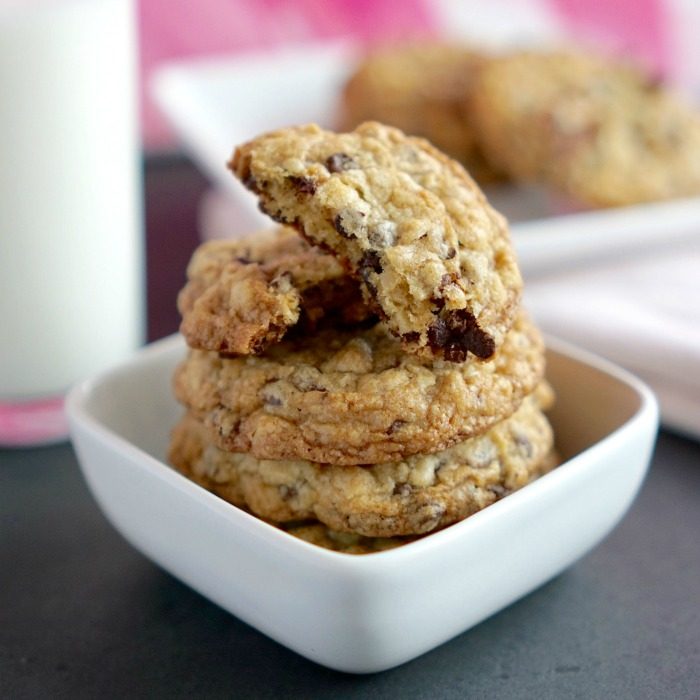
[175,313,545,464]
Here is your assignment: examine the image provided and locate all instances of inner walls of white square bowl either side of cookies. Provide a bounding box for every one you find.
[78,337,642,470]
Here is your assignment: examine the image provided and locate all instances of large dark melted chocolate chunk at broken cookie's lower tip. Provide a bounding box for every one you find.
[428,309,496,362]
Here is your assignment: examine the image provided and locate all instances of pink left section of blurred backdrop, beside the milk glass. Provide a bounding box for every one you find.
[139,0,438,147]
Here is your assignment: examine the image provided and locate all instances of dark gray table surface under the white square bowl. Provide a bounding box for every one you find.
[0,156,700,699]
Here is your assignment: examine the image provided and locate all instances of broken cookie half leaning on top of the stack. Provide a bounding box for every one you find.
[229,122,522,362]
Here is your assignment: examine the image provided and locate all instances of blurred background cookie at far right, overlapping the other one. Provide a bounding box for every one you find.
[470,52,700,207]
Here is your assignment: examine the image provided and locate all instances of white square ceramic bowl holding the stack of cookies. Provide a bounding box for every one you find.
[67,337,658,673]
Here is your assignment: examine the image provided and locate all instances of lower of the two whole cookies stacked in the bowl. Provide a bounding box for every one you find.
[170,386,553,537]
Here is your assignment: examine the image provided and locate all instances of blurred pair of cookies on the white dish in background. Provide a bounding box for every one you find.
[340,42,700,207]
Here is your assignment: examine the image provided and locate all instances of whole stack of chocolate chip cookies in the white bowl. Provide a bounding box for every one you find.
[169,123,554,553]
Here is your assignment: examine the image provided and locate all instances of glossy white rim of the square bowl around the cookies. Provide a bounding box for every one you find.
[65,334,658,574]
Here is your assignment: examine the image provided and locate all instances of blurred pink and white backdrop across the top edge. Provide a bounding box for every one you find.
[138,0,700,150]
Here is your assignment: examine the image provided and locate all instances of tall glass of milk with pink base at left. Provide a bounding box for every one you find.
[0,0,144,446]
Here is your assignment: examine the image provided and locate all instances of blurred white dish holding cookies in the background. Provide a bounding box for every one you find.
[152,37,700,274]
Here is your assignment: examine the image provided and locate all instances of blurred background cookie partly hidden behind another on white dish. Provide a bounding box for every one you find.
[341,41,501,183]
